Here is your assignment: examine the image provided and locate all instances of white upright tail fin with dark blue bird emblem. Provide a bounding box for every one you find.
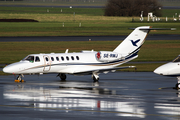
[113,26,151,55]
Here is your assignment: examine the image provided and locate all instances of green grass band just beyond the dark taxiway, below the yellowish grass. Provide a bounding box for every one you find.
[0,20,180,36]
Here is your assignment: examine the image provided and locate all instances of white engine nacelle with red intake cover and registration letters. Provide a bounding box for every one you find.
[95,51,122,62]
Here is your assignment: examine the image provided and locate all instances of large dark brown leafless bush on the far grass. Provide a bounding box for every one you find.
[104,0,162,17]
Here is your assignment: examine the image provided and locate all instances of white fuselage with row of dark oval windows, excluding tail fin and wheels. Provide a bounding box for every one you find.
[3,51,137,74]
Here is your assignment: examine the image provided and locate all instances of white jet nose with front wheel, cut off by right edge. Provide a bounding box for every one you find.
[154,55,180,89]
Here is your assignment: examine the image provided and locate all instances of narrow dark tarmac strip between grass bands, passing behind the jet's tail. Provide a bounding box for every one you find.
[0,34,180,42]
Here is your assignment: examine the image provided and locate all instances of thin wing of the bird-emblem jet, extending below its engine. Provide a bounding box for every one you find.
[74,66,135,74]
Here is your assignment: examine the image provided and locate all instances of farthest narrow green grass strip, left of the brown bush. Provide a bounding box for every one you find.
[0,7,104,16]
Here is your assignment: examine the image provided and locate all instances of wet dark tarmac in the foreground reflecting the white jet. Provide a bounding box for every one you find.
[0,72,180,120]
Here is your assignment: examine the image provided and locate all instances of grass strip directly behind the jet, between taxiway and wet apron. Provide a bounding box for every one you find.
[0,40,180,64]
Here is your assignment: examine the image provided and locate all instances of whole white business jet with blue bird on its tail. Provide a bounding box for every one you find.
[3,26,157,81]
